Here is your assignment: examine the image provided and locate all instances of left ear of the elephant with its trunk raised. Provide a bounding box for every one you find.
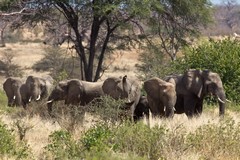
[102,77,122,99]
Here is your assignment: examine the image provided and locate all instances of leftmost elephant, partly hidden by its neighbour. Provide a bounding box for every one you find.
[3,77,23,107]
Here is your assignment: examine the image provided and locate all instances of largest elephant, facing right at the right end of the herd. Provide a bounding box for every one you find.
[166,69,226,118]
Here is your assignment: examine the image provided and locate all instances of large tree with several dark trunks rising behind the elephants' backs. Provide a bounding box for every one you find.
[1,0,154,81]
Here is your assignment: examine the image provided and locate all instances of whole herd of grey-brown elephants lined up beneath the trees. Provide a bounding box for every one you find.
[3,69,226,120]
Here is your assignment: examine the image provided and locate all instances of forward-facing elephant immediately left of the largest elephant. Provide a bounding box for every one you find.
[143,77,177,118]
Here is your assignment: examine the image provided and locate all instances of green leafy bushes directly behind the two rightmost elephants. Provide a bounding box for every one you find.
[138,39,240,102]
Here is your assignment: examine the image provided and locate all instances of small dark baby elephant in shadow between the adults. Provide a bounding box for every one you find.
[133,95,150,123]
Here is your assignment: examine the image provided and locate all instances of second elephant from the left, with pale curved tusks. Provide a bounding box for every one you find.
[20,76,53,108]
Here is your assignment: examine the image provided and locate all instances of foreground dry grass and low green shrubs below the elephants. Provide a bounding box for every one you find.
[0,93,240,160]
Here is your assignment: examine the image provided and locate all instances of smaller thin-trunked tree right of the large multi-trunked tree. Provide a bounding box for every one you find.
[148,0,212,61]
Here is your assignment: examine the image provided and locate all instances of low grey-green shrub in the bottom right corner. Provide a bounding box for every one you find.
[186,118,240,159]
